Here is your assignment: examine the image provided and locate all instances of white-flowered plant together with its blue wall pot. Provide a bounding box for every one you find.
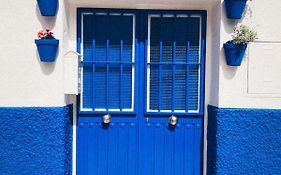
[223,25,257,66]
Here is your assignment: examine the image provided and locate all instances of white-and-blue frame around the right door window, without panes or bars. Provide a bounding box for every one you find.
[144,10,207,116]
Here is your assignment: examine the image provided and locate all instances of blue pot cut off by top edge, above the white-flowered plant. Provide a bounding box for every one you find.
[224,0,247,19]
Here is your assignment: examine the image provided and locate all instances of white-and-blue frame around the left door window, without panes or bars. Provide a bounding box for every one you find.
[77,8,137,114]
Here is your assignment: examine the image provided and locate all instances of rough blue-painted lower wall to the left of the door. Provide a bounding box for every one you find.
[0,106,72,175]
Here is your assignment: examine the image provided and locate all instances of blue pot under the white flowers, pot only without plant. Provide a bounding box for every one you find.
[223,41,247,66]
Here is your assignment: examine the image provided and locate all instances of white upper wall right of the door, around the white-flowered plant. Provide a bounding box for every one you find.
[218,0,281,109]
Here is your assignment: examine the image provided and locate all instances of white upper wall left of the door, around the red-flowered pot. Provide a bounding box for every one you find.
[0,0,65,106]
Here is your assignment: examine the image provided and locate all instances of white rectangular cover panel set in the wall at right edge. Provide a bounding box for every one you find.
[247,42,281,97]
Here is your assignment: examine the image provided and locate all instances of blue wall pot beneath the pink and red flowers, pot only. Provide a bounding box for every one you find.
[35,39,59,62]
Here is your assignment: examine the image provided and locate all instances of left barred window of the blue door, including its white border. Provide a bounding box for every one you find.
[81,12,135,111]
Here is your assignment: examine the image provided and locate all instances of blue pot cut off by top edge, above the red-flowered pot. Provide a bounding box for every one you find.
[37,0,58,16]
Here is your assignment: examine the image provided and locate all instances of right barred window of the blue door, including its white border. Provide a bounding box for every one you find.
[146,13,204,114]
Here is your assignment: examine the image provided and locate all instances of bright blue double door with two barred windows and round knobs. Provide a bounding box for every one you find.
[77,9,206,175]
